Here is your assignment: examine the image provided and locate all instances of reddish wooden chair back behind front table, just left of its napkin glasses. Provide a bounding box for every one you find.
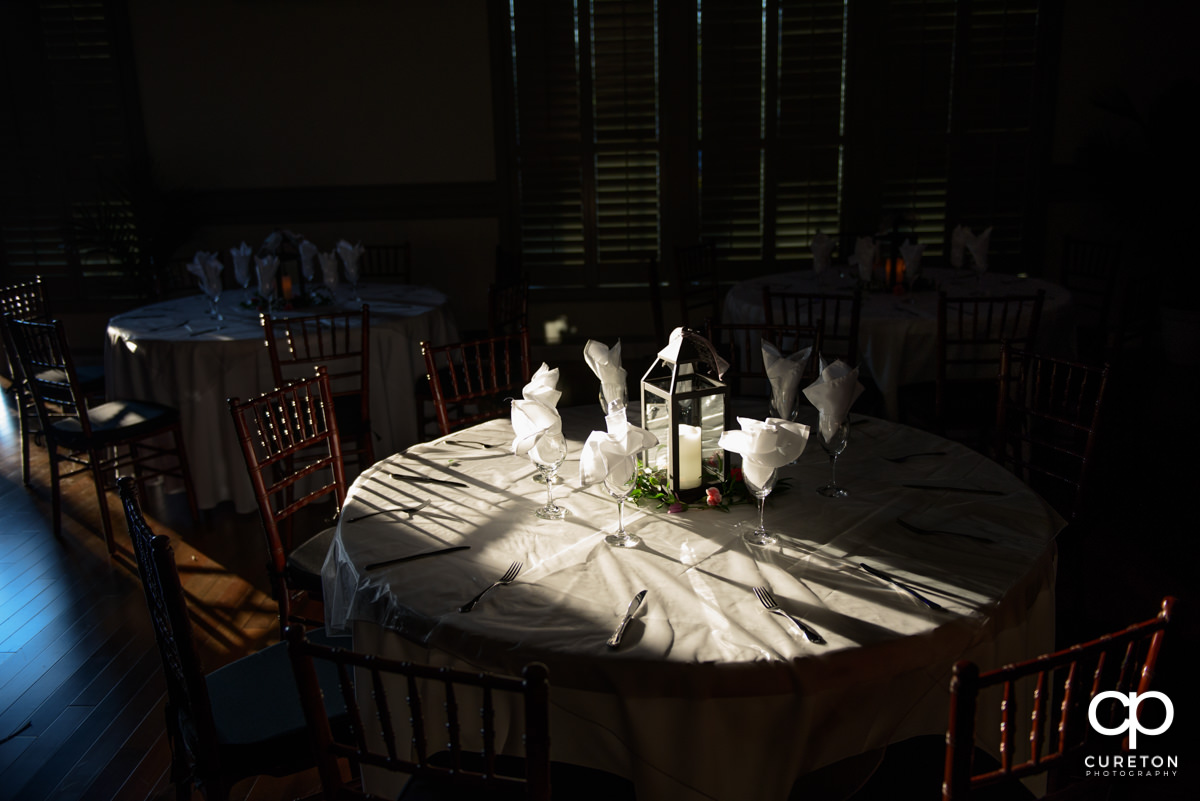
[421,329,529,435]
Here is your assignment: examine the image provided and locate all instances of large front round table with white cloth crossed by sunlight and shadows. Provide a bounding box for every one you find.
[323,408,1063,801]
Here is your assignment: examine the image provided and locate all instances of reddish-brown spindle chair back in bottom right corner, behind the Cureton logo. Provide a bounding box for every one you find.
[942,597,1175,801]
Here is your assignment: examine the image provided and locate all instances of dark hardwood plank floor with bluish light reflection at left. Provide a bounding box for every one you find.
[0,354,1200,801]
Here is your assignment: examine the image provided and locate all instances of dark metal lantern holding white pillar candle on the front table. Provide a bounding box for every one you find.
[642,329,730,501]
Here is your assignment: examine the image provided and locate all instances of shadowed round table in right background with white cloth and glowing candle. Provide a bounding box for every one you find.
[721,267,1075,420]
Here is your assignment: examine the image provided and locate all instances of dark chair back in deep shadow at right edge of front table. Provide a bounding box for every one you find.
[994,343,1109,519]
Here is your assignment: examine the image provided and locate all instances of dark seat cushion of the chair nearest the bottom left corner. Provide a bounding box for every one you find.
[205,631,350,776]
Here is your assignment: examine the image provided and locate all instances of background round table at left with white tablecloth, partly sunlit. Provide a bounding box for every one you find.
[104,284,457,513]
